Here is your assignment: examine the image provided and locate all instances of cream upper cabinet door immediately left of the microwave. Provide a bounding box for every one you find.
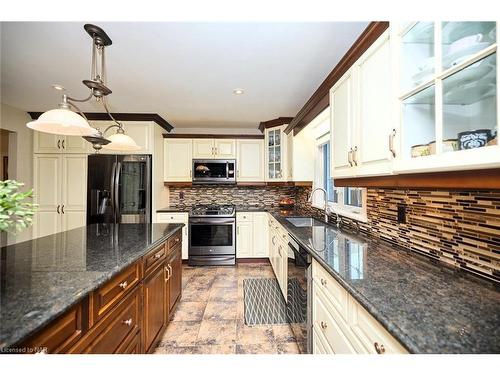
[163,138,193,182]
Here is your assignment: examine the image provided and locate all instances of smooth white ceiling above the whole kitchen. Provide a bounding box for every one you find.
[1,22,368,130]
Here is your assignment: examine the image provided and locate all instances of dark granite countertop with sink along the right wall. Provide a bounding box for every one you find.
[269,210,500,353]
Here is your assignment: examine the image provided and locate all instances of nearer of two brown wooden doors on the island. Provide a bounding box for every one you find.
[144,266,168,352]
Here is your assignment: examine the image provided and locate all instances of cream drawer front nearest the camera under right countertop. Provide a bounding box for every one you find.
[349,297,408,354]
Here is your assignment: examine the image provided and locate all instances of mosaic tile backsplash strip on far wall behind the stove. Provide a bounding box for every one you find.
[169,185,296,206]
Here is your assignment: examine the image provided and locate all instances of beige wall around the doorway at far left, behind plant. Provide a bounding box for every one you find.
[0,103,33,244]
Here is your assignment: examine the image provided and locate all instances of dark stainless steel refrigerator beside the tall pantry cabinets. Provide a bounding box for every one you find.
[87,155,151,224]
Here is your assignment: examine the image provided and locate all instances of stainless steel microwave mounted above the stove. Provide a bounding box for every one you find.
[193,159,236,184]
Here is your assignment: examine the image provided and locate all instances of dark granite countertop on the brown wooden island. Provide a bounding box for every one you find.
[0,224,184,349]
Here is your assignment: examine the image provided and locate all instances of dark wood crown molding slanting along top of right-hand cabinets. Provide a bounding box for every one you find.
[285,22,389,135]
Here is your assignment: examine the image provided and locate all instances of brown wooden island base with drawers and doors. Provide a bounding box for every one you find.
[17,228,187,354]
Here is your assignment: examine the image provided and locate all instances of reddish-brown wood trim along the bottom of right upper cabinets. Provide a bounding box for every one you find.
[335,168,500,190]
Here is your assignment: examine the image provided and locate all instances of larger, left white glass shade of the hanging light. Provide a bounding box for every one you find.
[26,108,96,137]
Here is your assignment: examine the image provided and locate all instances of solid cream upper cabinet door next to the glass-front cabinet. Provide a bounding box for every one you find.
[353,31,397,177]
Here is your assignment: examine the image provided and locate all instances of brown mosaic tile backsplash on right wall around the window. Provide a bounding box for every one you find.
[296,188,500,282]
